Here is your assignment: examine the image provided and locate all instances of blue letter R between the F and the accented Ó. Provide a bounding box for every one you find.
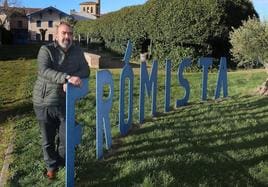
[96,70,114,159]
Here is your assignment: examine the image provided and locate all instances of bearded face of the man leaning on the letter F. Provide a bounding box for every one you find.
[56,25,73,50]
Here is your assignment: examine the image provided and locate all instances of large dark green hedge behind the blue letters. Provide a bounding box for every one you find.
[76,0,258,69]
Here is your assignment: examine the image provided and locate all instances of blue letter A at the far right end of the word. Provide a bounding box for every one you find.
[215,57,228,99]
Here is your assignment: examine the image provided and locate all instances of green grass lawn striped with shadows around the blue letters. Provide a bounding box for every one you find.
[0,60,268,186]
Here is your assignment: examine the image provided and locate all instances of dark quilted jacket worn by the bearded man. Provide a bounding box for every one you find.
[33,43,89,106]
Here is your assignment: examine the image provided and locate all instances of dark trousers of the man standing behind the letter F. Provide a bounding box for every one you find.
[34,106,66,171]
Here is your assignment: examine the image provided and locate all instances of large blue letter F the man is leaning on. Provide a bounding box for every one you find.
[65,79,88,187]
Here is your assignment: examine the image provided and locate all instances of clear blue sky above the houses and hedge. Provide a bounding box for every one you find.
[14,0,268,21]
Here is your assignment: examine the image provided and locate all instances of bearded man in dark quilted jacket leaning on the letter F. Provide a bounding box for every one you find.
[33,22,89,179]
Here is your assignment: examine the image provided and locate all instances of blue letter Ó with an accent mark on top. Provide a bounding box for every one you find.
[119,42,134,135]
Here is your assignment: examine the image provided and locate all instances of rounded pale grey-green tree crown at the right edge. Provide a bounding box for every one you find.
[230,18,268,67]
